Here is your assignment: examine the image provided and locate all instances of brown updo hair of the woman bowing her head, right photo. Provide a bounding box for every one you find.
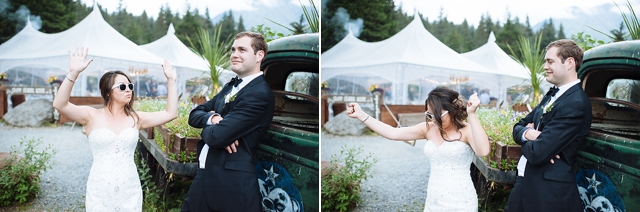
[424,86,468,141]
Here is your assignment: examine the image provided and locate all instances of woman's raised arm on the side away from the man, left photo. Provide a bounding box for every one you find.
[53,47,95,125]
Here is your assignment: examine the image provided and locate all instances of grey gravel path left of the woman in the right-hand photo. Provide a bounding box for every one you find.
[321,133,429,212]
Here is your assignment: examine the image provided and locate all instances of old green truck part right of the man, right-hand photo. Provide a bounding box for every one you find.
[574,41,640,211]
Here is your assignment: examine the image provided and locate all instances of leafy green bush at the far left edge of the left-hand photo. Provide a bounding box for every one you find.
[0,137,56,206]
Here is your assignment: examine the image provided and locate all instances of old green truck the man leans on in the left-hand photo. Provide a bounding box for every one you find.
[139,33,320,212]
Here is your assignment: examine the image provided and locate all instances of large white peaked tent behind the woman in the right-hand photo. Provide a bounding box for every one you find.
[322,16,520,104]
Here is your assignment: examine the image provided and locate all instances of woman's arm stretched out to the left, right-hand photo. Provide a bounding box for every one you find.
[347,102,427,141]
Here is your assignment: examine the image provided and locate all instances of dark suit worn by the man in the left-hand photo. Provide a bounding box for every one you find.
[182,75,275,211]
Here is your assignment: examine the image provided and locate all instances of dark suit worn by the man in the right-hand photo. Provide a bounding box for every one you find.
[507,83,591,212]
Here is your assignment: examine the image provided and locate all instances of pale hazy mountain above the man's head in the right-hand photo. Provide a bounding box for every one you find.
[533,3,628,43]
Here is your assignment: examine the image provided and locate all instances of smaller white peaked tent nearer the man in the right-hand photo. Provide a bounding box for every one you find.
[461,32,529,103]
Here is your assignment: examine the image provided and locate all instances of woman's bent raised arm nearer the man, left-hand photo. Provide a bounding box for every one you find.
[138,60,178,129]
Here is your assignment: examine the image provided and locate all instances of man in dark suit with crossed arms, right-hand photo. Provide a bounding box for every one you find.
[505,39,591,212]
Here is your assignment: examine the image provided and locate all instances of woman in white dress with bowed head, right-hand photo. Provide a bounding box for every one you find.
[347,87,491,211]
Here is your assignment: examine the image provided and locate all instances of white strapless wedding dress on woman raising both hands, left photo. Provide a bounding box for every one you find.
[85,128,142,211]
